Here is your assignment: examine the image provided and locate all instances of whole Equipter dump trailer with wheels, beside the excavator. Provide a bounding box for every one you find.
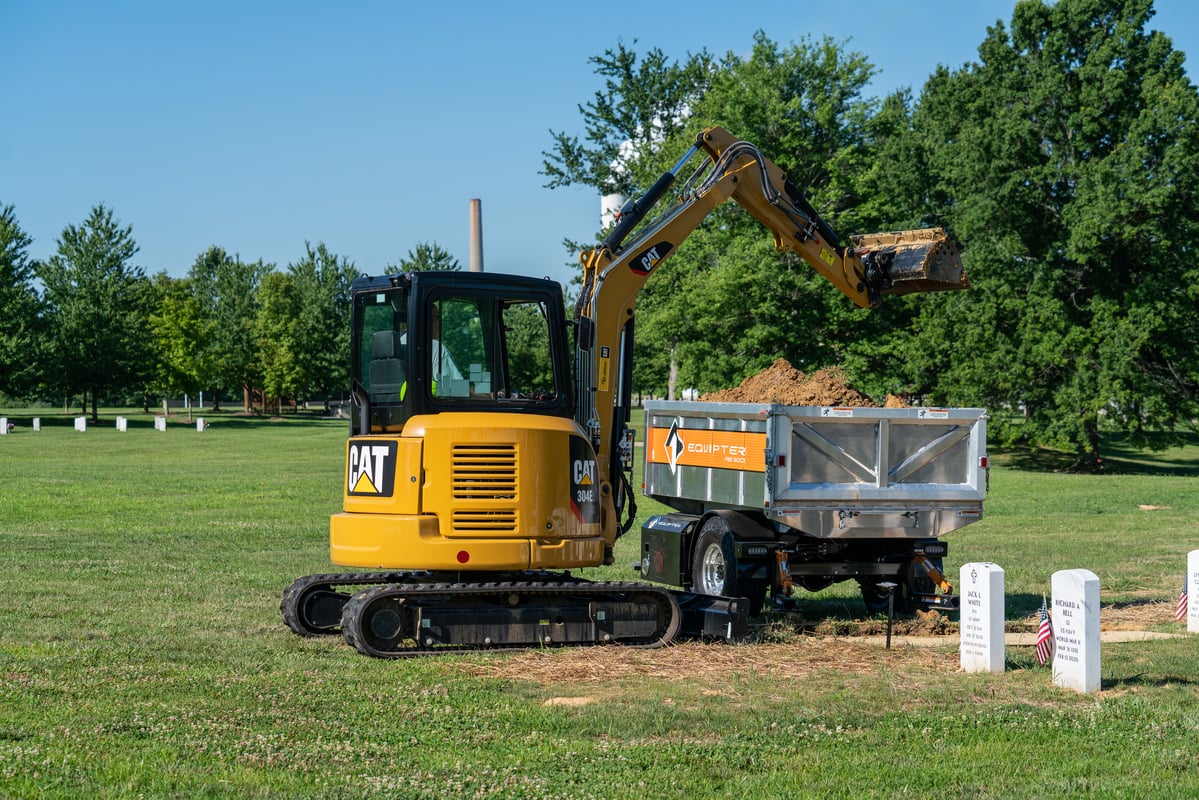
[638,401,988,612]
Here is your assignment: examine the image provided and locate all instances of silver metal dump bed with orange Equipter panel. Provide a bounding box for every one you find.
[645,401,987,539]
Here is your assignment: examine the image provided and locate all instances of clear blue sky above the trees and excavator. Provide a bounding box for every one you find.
[0,0,1199,291]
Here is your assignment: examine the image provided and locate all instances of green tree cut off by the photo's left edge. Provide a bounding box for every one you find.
[0,205,41,392]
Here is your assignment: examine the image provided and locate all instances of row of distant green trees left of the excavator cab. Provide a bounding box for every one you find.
[0,205,356,419]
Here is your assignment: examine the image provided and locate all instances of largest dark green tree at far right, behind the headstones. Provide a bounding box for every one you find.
[896,0,1199,469]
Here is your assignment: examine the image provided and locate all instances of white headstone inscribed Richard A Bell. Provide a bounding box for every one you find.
[1052,570,1101,694]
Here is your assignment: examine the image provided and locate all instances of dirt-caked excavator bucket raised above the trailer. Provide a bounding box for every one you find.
[850,228,970,294]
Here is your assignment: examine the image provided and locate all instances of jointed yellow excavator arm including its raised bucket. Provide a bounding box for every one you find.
[576,127,969,545]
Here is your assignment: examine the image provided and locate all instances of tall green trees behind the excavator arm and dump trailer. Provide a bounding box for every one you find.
[543,0,1199,469]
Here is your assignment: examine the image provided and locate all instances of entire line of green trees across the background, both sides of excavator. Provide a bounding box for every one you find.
[0,0,1199,469]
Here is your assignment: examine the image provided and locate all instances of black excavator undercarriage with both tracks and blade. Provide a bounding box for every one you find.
[279,572,748,658]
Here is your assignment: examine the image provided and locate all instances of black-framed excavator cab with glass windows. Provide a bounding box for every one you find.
[350,272,573,435]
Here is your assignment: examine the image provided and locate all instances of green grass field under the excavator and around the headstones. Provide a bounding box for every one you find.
[0,411,1199,800]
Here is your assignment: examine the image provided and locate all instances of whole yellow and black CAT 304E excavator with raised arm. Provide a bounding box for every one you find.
[281,128,966,657]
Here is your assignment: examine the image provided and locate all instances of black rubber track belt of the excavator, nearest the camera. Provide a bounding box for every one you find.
[342,576,682,658]
